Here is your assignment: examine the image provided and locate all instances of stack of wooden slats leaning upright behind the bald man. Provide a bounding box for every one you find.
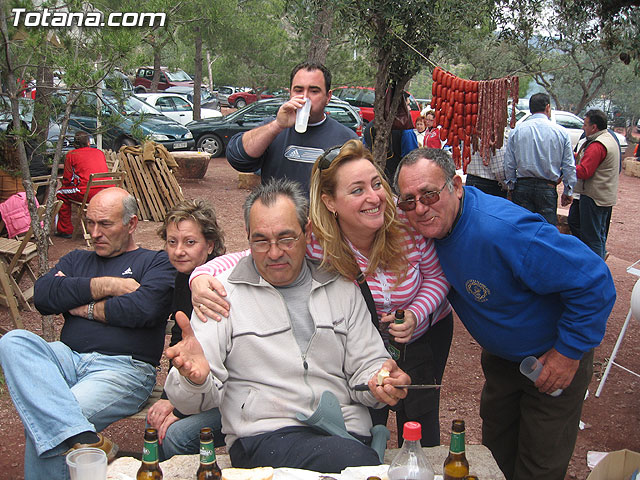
[107,142,184,222]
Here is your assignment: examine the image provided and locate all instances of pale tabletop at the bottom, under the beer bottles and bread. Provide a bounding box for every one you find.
[107,445,504,480]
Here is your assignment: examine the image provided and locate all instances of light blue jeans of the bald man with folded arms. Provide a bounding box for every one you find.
[0,330,156,480]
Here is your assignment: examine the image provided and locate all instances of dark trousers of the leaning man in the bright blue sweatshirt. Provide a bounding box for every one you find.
[480,350,593,480]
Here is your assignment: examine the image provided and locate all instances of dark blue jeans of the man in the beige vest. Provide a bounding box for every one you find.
[568,194,613,259]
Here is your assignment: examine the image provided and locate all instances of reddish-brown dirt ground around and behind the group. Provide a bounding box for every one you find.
[0,147,640,480]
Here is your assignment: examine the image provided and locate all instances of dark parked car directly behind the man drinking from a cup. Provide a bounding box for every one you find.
[187,98,362,157]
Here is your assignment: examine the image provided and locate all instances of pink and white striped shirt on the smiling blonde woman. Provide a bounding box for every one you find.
[190,213,451,341]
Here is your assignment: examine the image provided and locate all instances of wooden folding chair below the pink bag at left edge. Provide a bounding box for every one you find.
[0,200,62,328]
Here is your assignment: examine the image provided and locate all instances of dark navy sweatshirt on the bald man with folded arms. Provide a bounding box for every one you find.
[34,248,176,365]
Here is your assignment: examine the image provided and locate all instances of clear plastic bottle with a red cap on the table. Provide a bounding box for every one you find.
[388,422,433,480]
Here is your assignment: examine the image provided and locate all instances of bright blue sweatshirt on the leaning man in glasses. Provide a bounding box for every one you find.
[435,187,616,361]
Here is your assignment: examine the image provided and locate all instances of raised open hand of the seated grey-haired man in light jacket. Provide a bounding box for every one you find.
[165,312,210,385]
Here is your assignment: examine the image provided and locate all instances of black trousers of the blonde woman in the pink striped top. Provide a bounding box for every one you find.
[369,313,453,447]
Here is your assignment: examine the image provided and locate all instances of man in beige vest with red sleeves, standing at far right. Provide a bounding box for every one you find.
[569,110,620,259]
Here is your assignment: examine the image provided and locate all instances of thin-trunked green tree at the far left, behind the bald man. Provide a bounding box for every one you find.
[0,1,139,340]
